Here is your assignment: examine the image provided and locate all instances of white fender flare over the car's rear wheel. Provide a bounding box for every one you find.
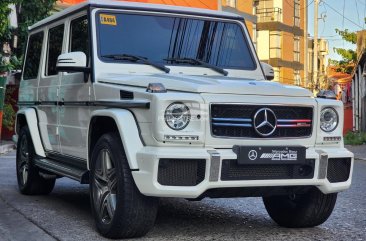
[15,108,46,157]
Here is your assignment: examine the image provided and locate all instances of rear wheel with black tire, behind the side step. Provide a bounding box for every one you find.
[16,126,56,195]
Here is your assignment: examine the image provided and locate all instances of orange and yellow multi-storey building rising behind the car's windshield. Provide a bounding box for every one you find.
[219,0,309,87]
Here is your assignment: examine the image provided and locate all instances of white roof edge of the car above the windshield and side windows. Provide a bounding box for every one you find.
[29,0,243,30]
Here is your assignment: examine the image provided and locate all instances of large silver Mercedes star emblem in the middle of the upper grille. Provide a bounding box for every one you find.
[253,108,277,137]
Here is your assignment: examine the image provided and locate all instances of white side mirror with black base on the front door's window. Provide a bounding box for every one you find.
[56,52,90,82]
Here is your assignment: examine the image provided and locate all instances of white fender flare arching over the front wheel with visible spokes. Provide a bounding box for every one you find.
[87,109,144,170]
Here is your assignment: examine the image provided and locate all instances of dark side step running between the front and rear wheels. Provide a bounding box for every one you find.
[34,158,89,184]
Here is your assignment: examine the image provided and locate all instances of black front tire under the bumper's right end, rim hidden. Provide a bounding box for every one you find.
[263,187,337,228]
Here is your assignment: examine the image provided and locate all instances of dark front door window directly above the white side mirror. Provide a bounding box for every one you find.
[70,16,89,57]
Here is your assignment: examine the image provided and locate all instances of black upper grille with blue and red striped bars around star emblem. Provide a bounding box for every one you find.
[211,104,313,138]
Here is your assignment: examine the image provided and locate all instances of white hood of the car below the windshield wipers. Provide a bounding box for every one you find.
[98,74,313,97]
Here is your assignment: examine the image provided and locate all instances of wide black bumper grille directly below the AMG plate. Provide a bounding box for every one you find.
[221,159,315,181]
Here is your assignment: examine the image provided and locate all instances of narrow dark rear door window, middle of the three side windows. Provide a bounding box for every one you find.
[45,25,64,76]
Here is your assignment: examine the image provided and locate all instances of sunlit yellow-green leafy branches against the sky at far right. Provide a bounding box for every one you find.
[330,28,357,74]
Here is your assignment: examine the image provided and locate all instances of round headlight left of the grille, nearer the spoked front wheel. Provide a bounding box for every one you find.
[165,102,191,131]
